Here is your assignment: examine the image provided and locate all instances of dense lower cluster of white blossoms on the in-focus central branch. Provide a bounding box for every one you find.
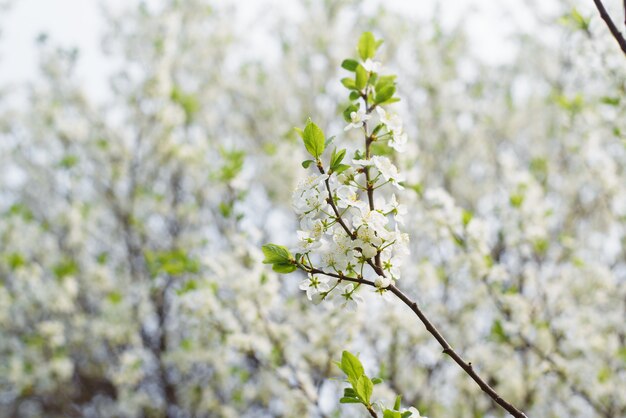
[292,150,409,308]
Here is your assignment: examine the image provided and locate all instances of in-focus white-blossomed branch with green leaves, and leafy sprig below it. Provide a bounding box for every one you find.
[263,32,525,417]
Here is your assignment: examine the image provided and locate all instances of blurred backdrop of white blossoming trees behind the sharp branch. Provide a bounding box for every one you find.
[0,0,626,418]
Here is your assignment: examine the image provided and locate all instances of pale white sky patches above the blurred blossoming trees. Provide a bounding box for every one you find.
[0,0,545,98]
